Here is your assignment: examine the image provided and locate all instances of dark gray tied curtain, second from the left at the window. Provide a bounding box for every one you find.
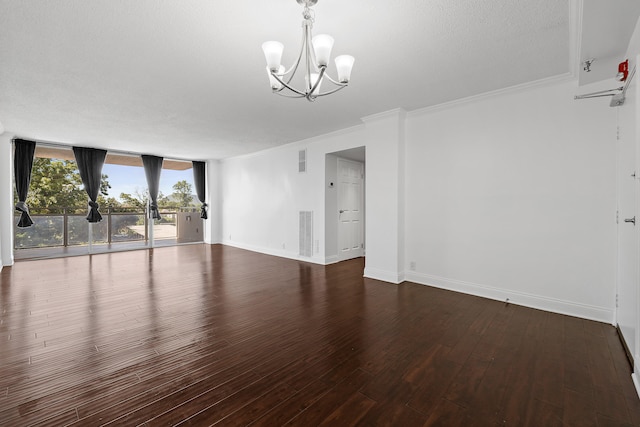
[73,147,107,222]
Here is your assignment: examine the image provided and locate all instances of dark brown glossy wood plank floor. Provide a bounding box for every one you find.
[0,245,640,426]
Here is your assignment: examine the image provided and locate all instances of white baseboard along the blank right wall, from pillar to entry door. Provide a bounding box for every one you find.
[404,270,614,324]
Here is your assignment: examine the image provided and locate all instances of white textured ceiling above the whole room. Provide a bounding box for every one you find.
[0,0,640,159]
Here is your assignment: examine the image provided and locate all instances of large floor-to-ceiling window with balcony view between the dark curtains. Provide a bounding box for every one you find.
[14,145,202,256]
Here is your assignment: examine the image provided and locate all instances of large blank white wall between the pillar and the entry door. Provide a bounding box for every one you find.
[405,78,616,322]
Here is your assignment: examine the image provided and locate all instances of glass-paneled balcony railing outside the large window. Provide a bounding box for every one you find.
[14,208,202,249]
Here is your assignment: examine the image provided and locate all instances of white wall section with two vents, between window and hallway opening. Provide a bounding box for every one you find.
[220,126,364,264]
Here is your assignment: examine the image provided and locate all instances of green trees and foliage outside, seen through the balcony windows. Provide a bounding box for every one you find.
[14,158,197,248]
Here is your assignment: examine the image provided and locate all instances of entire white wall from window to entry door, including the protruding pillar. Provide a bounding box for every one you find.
[221,80,616,322]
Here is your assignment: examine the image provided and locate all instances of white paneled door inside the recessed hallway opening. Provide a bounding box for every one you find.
[337,158,364,261]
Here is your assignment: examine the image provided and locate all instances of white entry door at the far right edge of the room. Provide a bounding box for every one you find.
[616,62,640,371]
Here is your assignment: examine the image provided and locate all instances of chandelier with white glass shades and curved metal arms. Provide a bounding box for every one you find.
[262,0,354,101]
